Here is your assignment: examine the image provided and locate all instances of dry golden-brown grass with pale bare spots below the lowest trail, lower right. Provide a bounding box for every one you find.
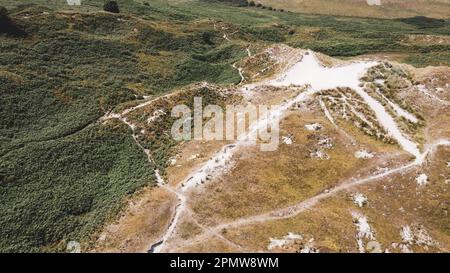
[209,148,450,252]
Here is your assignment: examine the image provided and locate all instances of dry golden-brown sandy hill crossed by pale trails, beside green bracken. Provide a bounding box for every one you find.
[93,45,450,252]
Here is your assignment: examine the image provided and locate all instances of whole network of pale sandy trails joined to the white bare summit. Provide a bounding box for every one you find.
[98,45,450,252]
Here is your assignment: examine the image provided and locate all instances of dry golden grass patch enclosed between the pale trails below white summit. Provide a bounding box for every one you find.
[191,101,406,224]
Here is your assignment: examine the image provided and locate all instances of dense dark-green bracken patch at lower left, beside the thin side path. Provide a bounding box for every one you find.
[0,121,154,252]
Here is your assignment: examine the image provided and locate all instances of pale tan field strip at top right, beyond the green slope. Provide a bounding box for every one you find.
[255,0,450,19]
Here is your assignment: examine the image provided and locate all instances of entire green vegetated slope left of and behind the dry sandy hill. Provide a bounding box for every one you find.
[0,0,450,252]
